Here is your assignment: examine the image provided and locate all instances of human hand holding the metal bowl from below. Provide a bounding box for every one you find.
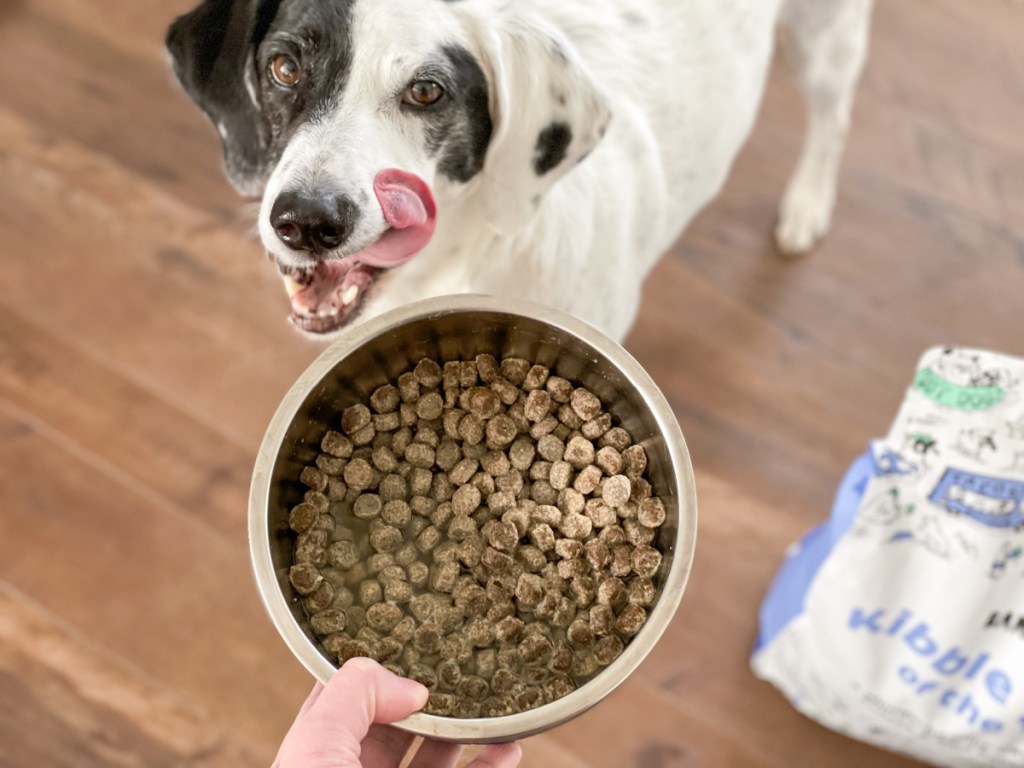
[271,657,522,768]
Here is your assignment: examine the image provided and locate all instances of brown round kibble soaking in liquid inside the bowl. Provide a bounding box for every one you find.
[288,354,667,717]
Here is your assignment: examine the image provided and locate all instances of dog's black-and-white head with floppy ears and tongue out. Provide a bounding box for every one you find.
[167,0,609,333]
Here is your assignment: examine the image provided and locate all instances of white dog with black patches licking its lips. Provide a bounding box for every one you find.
[166,0,871,340]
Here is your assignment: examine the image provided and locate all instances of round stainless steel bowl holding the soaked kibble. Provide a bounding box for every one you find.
[249,295,696,743]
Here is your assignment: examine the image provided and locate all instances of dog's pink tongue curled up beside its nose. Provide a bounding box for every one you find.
[353,168,437,267]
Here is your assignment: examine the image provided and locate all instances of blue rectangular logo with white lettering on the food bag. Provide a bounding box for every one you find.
[928,467,1024,529]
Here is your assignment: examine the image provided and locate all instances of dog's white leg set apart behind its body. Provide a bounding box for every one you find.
[775,0,872,256]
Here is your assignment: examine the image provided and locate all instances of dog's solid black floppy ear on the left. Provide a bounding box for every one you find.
[166,0,281,195]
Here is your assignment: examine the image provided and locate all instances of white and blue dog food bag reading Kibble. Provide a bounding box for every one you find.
[752,348,1024,768]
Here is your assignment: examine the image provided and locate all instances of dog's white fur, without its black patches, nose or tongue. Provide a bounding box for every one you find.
[259,0,871,339]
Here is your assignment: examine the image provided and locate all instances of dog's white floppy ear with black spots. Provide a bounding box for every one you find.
[482,11,611,234]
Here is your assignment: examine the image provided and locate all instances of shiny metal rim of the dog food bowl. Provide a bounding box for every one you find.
[249,294,697,743]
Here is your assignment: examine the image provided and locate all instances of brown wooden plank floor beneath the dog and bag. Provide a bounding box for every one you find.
[0,0,1024,768]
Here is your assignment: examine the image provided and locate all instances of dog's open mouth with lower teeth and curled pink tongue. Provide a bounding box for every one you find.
[278,168,437,334]
